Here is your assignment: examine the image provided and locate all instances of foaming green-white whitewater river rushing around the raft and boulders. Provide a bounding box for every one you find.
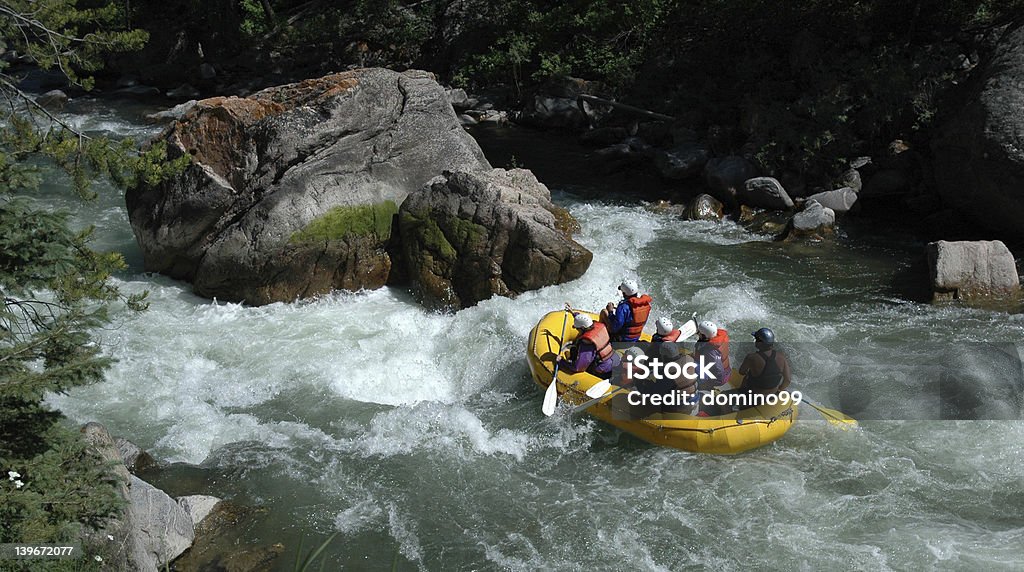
[36,97,1024,570]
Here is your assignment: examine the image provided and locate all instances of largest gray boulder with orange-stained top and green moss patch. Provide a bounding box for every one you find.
[125,69,490,305]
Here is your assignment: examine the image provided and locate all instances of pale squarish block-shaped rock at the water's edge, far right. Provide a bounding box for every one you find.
[928,240,1020,301]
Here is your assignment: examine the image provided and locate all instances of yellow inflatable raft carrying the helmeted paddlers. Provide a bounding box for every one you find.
[526,310,798,454]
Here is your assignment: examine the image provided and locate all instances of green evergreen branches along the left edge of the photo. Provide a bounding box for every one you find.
[0,0,181,570]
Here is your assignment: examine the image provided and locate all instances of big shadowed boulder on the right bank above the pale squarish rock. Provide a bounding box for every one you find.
[932,25,1024,238]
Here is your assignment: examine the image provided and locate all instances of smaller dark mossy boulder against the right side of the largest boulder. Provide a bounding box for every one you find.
[398,169,593,310]
